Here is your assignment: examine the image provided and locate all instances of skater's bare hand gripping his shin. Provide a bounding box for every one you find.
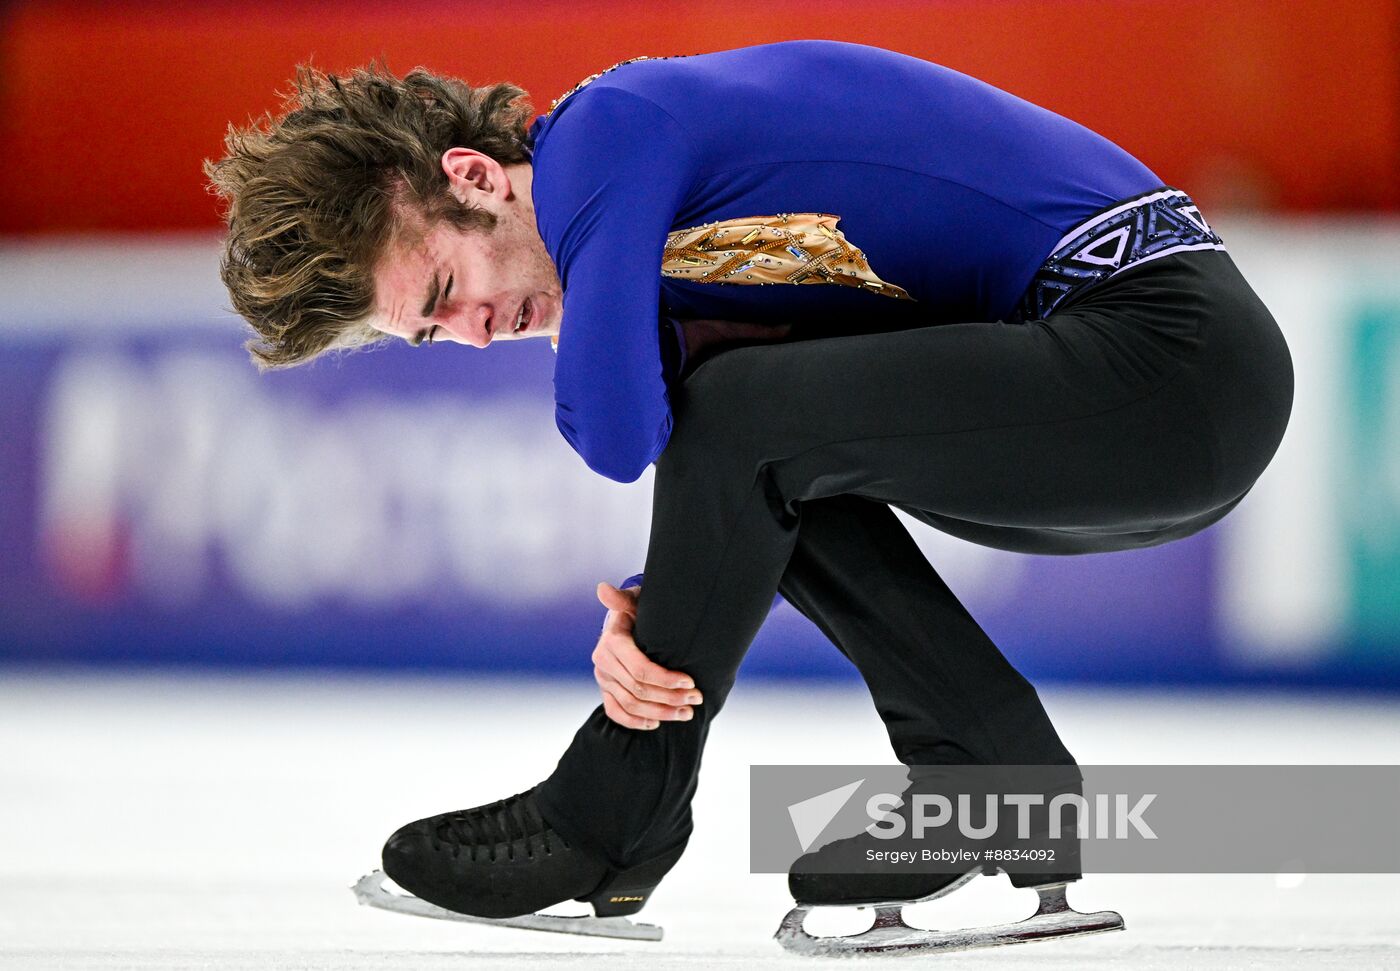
[594,583,701,729]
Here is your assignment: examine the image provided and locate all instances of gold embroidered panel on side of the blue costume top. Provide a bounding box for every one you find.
[661,213,914,301]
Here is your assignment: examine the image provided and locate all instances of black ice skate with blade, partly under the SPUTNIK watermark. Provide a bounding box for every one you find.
[774,777,1123,957]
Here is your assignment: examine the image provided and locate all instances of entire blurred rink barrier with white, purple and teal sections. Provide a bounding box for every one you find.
[0,221,1400,687]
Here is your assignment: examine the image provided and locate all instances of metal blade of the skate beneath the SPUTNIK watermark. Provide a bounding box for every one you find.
[773,883,1123,957]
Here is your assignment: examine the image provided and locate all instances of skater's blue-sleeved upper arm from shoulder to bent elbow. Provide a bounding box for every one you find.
[535,88,696,483]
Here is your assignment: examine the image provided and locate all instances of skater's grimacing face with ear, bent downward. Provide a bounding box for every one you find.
[371,148,564,347]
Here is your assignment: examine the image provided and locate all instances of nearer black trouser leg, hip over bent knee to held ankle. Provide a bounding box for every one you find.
[540,253,1292,865]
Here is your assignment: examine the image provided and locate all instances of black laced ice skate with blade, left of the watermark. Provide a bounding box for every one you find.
[353,789,683,940]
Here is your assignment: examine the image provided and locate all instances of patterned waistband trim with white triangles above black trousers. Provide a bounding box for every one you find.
[1015,189,1225,320]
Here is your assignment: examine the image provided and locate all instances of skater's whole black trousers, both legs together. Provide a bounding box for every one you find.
[538,250,1294,866]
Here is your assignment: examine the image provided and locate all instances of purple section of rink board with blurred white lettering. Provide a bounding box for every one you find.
[0,336,1211,677]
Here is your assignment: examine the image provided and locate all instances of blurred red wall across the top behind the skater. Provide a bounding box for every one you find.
[0,0,1400,234]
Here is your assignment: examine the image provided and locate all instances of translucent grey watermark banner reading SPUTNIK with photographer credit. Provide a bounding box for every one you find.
[749,765,1400,873]
